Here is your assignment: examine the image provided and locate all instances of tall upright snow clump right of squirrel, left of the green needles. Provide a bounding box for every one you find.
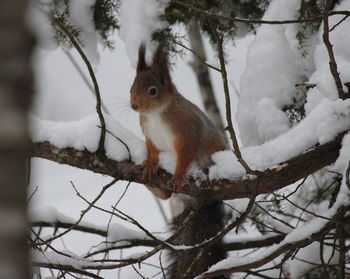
[236,0,301,146]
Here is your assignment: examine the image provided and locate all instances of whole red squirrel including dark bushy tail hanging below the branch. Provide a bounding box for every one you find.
[130,44,227,279]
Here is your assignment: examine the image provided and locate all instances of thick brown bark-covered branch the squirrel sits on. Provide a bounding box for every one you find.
[32,133,344,200]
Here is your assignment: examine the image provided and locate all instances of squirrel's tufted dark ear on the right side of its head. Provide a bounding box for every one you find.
[151,43,171,84]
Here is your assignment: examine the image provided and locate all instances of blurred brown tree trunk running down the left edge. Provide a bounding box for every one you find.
[0,0,33,279]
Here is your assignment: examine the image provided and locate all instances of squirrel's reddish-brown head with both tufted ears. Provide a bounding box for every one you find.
[130,44,173,113]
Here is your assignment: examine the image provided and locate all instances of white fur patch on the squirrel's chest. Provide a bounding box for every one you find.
[143,110,175,151]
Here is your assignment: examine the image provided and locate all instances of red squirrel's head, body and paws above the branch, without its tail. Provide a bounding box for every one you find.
[130,44,226,199]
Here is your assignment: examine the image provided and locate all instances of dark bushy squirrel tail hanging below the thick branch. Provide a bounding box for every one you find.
[167,201,229,279]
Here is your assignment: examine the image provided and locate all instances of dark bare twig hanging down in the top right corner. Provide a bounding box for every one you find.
[322,0,347,100]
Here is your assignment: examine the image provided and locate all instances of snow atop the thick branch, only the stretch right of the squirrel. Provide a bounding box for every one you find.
[209,98,350,182]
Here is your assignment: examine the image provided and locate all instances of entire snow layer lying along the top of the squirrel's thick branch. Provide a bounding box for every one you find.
[31,95,350,184]
